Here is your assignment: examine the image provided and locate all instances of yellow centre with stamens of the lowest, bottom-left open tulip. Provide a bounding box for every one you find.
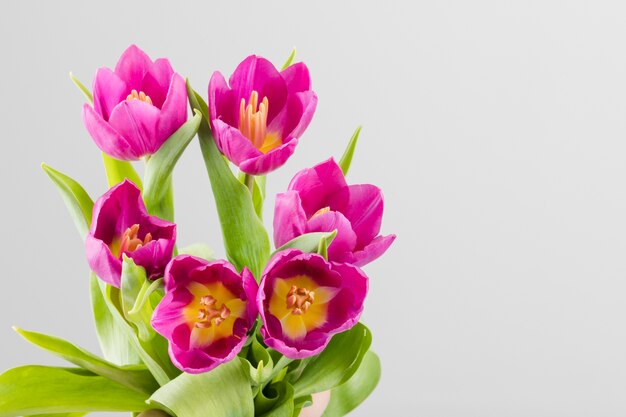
[183,281,246,348]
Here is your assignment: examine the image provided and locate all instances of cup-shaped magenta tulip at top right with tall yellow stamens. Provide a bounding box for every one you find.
[209,55,317,175]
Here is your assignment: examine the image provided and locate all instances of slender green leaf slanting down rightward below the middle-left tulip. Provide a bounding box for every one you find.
[98,281,180,385]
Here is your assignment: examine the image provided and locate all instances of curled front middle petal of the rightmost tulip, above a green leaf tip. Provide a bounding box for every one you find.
[307,211,357,259]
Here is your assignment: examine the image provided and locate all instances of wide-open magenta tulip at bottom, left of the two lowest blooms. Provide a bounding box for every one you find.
[152,255,258,374]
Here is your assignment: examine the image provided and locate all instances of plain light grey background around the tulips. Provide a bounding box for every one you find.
[0,1,626,417]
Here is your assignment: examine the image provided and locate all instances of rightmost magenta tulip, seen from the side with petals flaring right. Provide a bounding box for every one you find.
[274,158,396,266]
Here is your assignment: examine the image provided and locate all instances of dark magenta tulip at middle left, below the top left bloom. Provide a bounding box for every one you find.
[85,180,176,288]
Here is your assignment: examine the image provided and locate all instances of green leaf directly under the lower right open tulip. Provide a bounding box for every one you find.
[294,323,372,397]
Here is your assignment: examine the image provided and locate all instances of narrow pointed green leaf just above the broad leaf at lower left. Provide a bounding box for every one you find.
[14,327,158,394]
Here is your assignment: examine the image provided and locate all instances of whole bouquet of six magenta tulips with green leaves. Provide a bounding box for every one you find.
[0,46,395,417]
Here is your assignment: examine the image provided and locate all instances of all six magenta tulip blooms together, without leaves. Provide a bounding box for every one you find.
[83,46,395,373]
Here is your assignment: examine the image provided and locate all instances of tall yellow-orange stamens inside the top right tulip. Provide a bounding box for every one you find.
[239,91,282,153]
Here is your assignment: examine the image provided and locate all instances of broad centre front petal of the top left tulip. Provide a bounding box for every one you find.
[109,100,163,157]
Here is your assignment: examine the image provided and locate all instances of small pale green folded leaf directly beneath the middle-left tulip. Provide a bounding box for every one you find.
[121,255,156,342]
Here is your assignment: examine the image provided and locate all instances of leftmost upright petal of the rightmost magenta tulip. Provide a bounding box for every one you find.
[274,191,307,248]
